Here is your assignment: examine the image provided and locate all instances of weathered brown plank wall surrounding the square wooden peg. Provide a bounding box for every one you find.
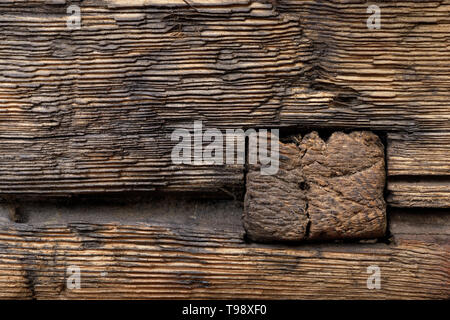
[0,0,450,299]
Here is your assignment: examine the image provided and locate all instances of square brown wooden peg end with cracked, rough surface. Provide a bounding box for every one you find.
[243,131,386,241]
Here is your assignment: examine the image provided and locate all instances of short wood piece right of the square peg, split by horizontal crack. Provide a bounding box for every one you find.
[387,131,450,208]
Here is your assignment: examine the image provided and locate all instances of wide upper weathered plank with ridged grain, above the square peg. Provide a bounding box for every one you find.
[0,0,450,200]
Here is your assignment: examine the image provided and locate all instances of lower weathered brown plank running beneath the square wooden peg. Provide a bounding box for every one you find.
[0,199,450,299]
